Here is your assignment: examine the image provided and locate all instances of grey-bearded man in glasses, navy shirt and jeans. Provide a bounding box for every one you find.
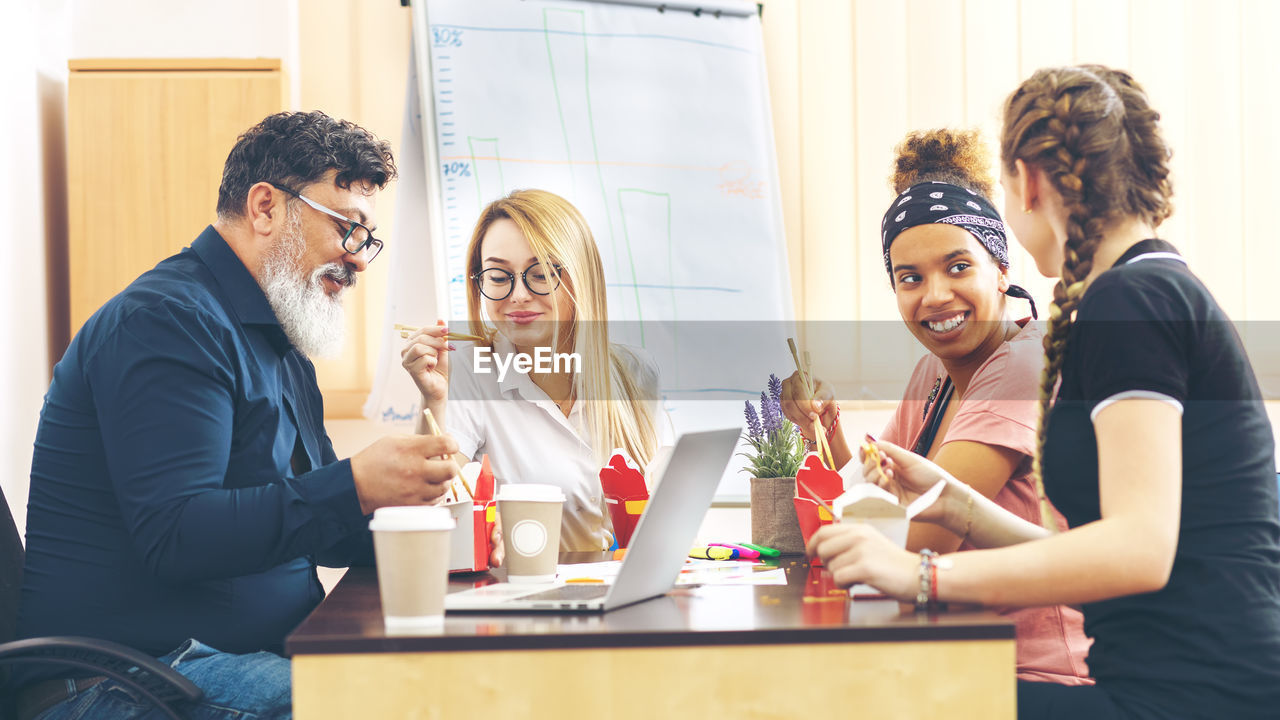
[13,113,457,719]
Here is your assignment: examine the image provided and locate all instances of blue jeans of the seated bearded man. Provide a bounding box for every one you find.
[37,639,293,720]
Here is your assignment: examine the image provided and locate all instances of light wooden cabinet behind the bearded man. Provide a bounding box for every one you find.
[68,58,285,334]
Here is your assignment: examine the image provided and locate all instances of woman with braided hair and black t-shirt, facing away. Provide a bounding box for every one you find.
[809,67,1280,720]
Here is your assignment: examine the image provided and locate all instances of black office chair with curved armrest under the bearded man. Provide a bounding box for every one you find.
[0,488,205,720]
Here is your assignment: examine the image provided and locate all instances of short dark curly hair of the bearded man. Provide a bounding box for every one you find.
[218,110,396,219]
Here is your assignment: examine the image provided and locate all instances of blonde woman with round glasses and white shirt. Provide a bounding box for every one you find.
[401,190,666,551]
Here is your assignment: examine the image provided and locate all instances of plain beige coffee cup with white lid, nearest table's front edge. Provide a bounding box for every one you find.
[369,506,457,634]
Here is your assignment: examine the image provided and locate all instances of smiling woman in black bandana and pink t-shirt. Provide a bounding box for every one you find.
[782,129,1091,685]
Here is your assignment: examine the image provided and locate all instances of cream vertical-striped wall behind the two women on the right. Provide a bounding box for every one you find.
[763,0,1280,400]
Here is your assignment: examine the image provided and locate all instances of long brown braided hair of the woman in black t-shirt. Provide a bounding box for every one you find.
[1001,65,1172,529]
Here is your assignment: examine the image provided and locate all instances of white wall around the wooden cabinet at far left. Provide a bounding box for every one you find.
[0,0,300,533]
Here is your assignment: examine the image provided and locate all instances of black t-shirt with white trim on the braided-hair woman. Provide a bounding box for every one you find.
[1044,240,1280,719]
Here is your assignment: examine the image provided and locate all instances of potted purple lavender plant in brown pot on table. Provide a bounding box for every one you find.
[739,374,804,553]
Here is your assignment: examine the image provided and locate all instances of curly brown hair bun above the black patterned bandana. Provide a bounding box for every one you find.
[890,128,995,197]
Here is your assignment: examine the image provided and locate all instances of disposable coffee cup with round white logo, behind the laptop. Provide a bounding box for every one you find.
[497,483,564,583]
